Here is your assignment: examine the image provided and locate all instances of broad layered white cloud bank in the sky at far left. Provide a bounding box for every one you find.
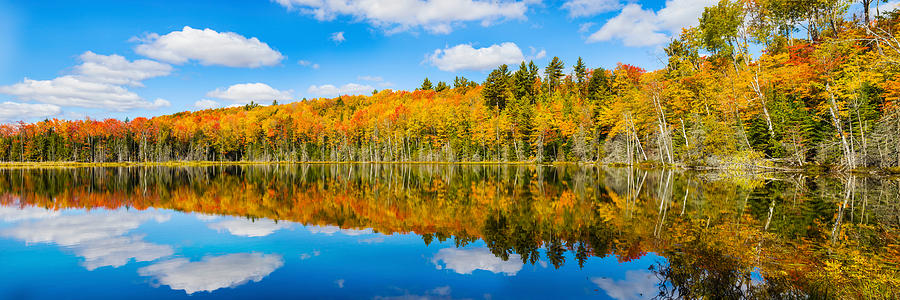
[0,51,171,113]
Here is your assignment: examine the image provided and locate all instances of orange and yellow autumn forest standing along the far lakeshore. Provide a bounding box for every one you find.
[0,0,900,170]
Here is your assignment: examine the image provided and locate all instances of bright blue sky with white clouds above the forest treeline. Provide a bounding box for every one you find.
[0,0,714,122]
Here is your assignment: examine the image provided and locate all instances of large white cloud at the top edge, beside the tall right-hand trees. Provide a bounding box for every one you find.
[587,0,716,47]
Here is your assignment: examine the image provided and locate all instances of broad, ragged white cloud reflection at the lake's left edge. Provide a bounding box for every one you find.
[0,211,173,270]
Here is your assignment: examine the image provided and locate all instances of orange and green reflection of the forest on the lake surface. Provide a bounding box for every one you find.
[0,164,900,298]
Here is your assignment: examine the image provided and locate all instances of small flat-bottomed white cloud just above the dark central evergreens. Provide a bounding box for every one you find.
[428,42,525,72]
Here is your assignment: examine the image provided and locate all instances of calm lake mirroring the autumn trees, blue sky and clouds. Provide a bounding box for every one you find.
[0,164,900,299]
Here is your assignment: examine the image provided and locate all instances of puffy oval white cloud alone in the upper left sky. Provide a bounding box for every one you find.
[134,26,284,68]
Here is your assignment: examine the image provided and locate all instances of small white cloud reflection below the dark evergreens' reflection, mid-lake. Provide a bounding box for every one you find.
[431,248,522,276]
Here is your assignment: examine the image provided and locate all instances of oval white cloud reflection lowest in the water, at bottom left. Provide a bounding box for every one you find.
[138,253,284,294]
